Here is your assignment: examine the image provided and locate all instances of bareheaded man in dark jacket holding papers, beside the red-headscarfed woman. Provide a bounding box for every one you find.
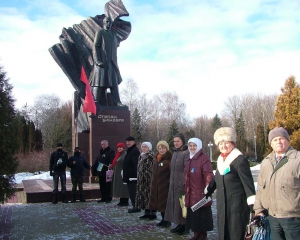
[92,140,115,203]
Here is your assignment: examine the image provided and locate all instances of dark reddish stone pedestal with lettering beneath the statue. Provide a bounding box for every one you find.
[73,107,130,183]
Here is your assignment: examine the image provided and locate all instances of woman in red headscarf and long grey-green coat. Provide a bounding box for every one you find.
[112,143,129,207]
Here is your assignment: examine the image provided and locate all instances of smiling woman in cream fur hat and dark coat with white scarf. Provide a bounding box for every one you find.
[206,127,255,240]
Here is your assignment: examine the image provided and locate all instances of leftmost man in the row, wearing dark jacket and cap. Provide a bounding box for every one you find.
[49,143,68,204]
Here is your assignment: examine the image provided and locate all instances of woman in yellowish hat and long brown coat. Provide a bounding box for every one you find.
[149,141,172,227]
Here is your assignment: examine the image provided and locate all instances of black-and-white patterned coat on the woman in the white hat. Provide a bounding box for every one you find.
[135,150,154,209]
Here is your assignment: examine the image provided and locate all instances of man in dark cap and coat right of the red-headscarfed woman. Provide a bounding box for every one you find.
[123,136,141,213]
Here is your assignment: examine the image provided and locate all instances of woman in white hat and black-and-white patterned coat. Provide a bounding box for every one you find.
[135,142,156,220]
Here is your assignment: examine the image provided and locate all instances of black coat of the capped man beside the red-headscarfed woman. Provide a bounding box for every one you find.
[123,144,140,183]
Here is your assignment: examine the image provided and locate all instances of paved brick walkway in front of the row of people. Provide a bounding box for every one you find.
[0,197,218,240]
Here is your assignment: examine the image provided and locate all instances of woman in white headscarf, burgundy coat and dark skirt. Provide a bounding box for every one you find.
[184,138,214,240]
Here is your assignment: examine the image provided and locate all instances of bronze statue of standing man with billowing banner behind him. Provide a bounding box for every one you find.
[49,0,131,131]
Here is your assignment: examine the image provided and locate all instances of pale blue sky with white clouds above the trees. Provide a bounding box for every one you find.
[0,0,300,117]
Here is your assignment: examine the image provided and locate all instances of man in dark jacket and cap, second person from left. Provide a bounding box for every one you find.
[67,147,91,203]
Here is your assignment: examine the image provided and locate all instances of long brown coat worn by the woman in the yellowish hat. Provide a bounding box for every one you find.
[149,151,172,212]
